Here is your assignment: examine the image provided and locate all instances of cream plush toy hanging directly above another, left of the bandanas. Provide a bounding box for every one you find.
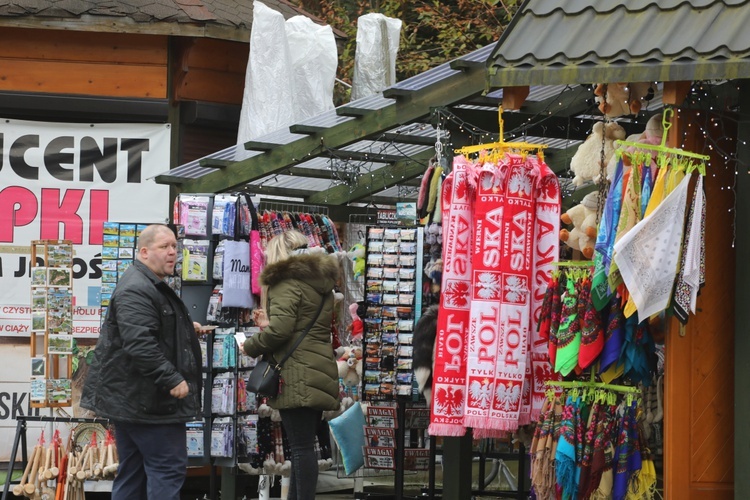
[570,122,625,186]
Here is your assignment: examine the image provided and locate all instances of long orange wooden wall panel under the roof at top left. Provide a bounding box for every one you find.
[0,28,167,99]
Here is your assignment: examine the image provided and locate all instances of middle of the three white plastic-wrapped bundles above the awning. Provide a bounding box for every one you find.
[285,16,338,122]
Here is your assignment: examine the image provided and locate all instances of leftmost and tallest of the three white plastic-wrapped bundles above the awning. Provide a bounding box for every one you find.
[235,2,294,156]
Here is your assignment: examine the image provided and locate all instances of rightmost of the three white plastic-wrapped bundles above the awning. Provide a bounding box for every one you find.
[352,13,402,100]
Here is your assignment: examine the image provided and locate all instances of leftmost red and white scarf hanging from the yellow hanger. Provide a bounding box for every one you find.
[429,156,474,436]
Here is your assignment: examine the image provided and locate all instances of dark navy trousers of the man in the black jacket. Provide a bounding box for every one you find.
[112,422,187,500]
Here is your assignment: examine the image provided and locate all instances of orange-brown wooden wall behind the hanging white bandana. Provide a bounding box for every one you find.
[664,107,735,500]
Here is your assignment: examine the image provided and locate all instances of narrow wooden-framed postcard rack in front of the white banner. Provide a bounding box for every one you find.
[30,240,73,408]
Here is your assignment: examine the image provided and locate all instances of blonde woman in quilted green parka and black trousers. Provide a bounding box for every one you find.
[244,231,339,500]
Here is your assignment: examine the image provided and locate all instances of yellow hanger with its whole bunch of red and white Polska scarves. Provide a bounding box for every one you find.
[430,108,560,437]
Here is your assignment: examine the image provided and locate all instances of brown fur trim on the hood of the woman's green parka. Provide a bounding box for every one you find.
[260,252,339,294]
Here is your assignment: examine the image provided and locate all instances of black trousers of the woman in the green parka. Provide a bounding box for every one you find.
[279,408,323,500]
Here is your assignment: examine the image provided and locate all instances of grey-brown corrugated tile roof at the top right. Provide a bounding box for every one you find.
[488,0,750,87]
